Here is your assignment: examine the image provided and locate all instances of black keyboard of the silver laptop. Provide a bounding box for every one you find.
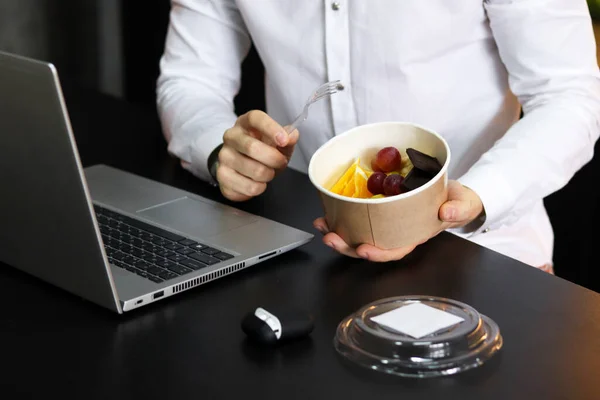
[94,205,233,283]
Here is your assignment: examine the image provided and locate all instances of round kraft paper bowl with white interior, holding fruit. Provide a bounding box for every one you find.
[308,122,450,249]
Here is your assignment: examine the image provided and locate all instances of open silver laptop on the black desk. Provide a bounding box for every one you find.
[0,52,313,313]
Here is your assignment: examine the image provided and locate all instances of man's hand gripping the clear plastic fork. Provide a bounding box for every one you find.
[217,110,298,201]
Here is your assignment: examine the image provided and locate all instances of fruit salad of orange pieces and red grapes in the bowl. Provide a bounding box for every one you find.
[330,146,442,199]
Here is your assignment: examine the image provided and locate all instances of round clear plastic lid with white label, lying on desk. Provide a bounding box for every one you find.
[334,296,502,378]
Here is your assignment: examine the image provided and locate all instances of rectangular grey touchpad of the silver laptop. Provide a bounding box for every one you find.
[138,197,257,238]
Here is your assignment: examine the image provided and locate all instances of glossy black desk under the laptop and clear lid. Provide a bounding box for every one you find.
[0,88,600,400]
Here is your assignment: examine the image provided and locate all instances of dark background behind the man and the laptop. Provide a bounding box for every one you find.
[0,0,600,292]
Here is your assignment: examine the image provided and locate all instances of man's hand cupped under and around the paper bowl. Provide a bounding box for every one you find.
[313,181,483,262]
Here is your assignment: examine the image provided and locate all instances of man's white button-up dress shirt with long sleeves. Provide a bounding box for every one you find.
[157,0,600,267]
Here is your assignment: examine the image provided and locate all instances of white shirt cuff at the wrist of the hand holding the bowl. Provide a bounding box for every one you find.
[454,165,515,236]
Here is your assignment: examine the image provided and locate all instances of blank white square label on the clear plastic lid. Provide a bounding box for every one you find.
[371,303,464,339]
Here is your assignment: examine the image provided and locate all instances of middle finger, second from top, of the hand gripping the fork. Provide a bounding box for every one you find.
[223,127,288,169]
